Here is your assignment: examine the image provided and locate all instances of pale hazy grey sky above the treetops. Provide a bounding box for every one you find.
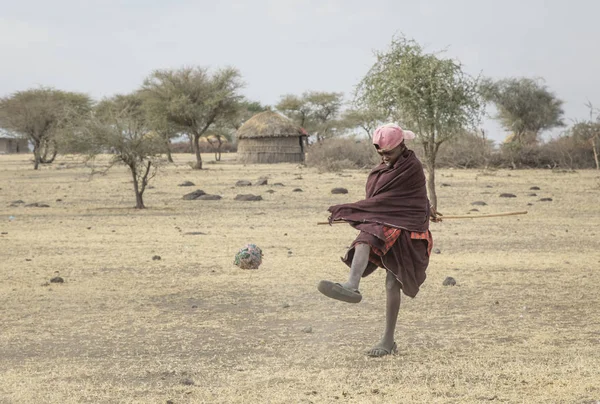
[0,0,600,139]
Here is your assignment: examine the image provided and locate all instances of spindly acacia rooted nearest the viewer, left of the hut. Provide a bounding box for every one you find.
[67,93,165,209]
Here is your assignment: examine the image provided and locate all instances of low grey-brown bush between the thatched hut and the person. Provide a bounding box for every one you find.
[306,138,380,172]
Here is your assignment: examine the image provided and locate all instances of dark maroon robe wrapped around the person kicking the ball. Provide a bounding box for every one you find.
[329,150,429,297]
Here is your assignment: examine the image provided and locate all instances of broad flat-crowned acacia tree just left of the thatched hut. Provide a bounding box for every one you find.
[141,67,243,169]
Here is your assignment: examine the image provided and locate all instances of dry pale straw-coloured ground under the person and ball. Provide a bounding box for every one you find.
[0,155,600,404]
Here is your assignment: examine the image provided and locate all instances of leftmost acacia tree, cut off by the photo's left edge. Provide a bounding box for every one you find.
[0,87,92,170]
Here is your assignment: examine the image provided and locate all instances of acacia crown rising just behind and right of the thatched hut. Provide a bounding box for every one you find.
[275,91,344,141]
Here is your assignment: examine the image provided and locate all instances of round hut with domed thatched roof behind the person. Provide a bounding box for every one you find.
[236,111,308,164]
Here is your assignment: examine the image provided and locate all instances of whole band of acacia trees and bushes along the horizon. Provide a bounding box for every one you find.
[0,36,600,208]
